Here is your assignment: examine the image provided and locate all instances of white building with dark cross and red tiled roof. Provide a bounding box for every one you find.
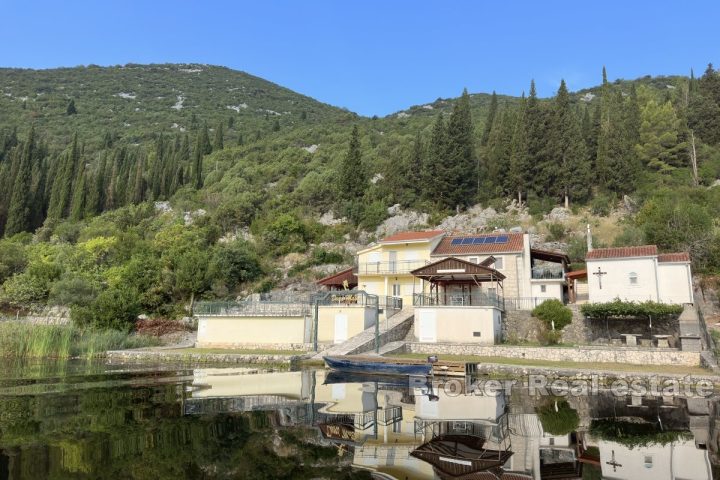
[585,245,693,304]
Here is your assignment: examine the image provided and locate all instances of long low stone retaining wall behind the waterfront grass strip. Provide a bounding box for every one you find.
[407,343,700,366]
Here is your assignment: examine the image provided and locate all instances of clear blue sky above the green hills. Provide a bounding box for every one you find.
[0,0,720,115]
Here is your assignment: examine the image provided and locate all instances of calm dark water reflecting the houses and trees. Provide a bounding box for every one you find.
[0,363,720,480]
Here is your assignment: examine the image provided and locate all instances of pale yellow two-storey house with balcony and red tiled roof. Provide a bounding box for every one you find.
[357,230,444,306]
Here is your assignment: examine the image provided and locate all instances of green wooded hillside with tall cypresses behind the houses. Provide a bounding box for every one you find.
[0,65,720,330]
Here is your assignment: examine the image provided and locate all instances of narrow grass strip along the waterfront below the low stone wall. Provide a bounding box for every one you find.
[388,353,712,375]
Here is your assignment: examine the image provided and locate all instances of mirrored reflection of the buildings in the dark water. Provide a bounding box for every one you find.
[184,369,712,480]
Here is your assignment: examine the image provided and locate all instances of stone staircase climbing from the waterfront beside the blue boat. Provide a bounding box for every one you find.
[312,307,415,360]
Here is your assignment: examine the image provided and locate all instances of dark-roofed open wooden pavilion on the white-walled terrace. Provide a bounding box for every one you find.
[410,257,505,305]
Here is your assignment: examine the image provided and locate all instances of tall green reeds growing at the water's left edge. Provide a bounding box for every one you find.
[0,322,159,359]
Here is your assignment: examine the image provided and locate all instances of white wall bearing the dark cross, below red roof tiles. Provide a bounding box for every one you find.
[587,257,657,303]
